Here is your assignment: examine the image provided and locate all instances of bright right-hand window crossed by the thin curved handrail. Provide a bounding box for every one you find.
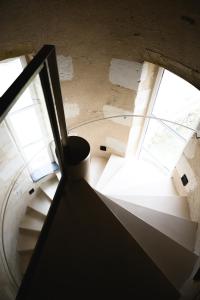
[140,70,200,172]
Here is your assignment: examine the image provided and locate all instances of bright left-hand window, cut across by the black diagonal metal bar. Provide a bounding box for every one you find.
[0,58,54,176]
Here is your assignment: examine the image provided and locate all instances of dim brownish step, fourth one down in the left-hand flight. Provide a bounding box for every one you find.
[17,231,39,252]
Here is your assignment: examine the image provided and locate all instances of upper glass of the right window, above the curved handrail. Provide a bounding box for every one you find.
[152,70,200,140]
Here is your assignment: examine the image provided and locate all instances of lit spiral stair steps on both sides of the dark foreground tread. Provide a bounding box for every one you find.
[18,155,199,298]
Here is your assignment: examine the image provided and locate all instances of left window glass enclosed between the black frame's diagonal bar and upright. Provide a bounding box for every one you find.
[6,70,55,178]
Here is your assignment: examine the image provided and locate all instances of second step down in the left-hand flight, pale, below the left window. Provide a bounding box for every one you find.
[28,192,51,216]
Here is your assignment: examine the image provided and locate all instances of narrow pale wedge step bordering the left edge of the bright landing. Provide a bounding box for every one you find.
[95,154,124,192]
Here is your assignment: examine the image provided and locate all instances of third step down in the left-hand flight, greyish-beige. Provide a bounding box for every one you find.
[19,211,45,231]
